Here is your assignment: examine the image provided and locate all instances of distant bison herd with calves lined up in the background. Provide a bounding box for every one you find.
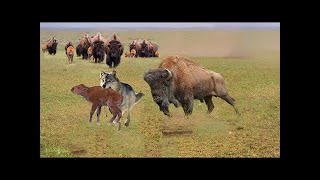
[41,32,160,68]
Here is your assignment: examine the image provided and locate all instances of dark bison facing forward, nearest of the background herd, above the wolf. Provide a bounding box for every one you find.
[106,40,124,68]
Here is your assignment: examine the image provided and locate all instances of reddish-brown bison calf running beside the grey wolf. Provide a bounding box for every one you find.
[71,84,123,130]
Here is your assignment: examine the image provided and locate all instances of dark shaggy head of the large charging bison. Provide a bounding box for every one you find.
[144,68,180,116]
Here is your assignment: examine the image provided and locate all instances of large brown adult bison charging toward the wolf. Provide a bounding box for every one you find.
[144,56,239,116]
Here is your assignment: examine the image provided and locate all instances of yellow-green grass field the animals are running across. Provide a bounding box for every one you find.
[40,31,280,157]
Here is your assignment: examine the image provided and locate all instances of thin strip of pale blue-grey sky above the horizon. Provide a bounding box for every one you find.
[40,22,280,30]
